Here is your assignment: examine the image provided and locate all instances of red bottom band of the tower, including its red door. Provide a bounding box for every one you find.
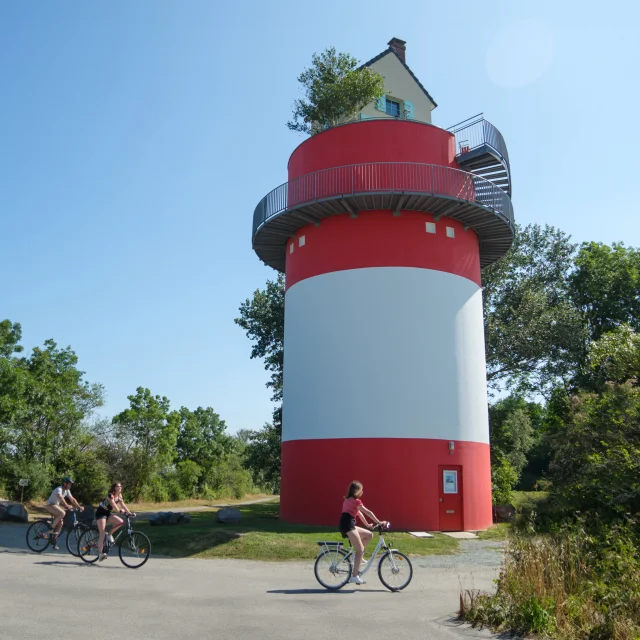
[280,438,492,531]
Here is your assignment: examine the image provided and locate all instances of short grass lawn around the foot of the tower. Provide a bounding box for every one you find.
[135,501,458,560]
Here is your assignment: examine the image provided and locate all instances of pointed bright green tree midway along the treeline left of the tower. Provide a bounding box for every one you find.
[113,387,180,500]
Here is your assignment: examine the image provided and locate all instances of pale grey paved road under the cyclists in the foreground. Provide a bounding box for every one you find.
[0,525,499,640]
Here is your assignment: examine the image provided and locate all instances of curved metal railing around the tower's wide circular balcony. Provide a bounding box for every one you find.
[253,162,514,236]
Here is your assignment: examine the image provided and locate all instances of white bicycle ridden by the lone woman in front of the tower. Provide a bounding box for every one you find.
[313,523,413,591]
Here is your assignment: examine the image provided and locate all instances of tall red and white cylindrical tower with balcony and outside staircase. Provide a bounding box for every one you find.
[253,40,514,531]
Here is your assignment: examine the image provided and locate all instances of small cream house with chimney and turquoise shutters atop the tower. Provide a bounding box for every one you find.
[358,38,438,123]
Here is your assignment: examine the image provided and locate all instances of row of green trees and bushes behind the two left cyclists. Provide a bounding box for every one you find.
[0,320,270,504]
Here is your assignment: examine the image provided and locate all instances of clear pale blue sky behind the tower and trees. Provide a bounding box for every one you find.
[0,0,640,431]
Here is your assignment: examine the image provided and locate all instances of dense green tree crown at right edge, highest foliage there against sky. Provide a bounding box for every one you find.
[570,242,640,340]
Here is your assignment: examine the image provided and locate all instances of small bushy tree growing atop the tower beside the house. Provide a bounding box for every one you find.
[287,47,384,135]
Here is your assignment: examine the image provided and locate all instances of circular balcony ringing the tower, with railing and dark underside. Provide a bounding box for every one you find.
[252,160,514,272]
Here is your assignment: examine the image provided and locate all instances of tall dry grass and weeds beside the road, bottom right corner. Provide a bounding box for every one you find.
[460,526,640,640]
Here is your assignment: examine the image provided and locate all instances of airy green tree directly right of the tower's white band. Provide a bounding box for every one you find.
[482,225,586,393]
